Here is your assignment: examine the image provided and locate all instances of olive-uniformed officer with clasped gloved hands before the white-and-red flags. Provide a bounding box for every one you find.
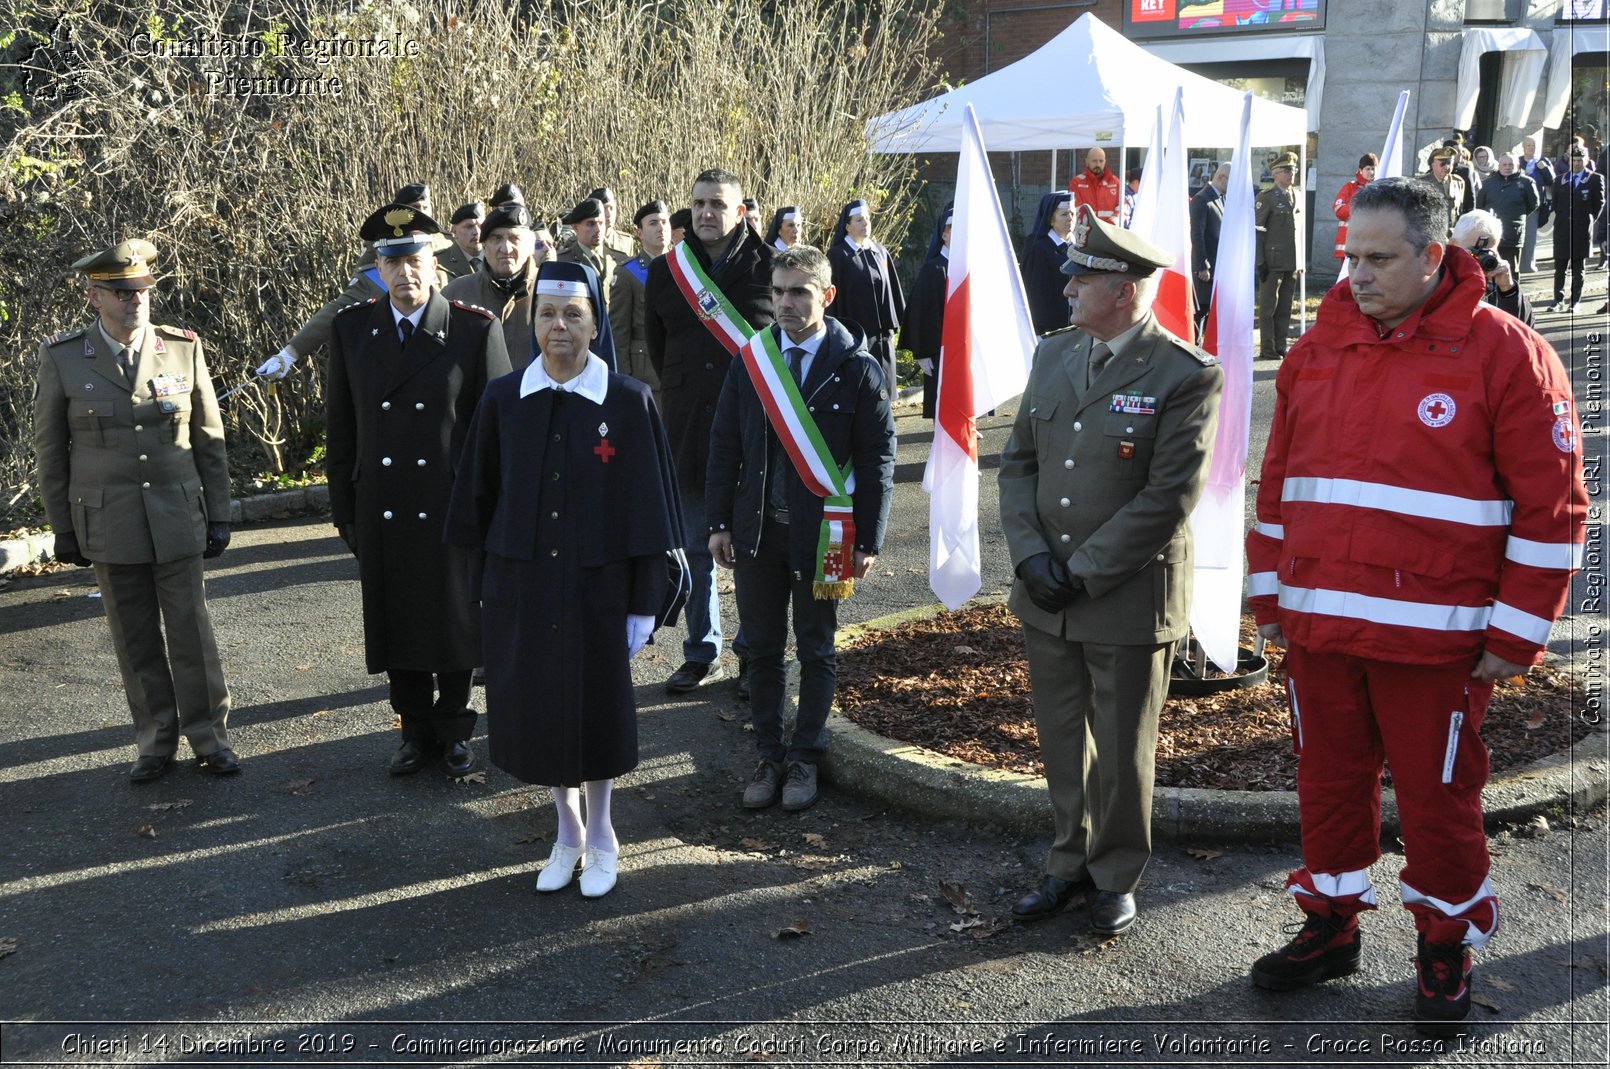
[1000,206,1224,934]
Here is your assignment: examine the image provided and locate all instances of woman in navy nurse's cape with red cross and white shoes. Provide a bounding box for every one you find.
[446,262,683,897]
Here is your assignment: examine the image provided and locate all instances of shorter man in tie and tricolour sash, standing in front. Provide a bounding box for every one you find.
[705,245,895,810]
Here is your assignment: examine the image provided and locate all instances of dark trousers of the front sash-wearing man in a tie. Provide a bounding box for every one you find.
[737,520,839,765]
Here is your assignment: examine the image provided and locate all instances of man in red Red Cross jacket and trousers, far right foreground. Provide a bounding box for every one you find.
[1246,179,1587,1032]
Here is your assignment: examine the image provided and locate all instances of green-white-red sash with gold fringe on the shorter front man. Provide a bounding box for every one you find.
[737,330,855,601]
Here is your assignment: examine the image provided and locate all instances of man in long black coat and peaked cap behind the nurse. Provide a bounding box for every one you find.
[327,204,509,776]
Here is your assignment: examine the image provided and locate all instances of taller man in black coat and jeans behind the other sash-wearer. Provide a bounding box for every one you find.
[642,169,771,694]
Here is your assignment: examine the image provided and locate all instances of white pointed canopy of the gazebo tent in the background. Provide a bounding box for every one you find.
[866,13,1307,160]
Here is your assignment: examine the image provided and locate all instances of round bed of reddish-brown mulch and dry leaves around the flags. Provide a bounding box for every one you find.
[837,605,1589,790]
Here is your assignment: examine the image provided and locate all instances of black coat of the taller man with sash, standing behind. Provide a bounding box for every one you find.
[642,225,773,496]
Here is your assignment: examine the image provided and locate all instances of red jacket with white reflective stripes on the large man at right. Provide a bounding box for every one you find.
[1246,251,1587,665]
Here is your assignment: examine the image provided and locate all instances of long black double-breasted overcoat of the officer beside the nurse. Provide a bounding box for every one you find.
[325,291,509,671]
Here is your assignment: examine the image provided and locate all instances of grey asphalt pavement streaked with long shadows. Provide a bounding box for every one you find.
[0,286,1610,1066]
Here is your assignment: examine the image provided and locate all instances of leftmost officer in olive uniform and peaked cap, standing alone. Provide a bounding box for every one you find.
[34,241,240,782]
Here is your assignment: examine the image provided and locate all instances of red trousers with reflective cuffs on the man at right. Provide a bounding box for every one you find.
[1286,646,1497,947]
